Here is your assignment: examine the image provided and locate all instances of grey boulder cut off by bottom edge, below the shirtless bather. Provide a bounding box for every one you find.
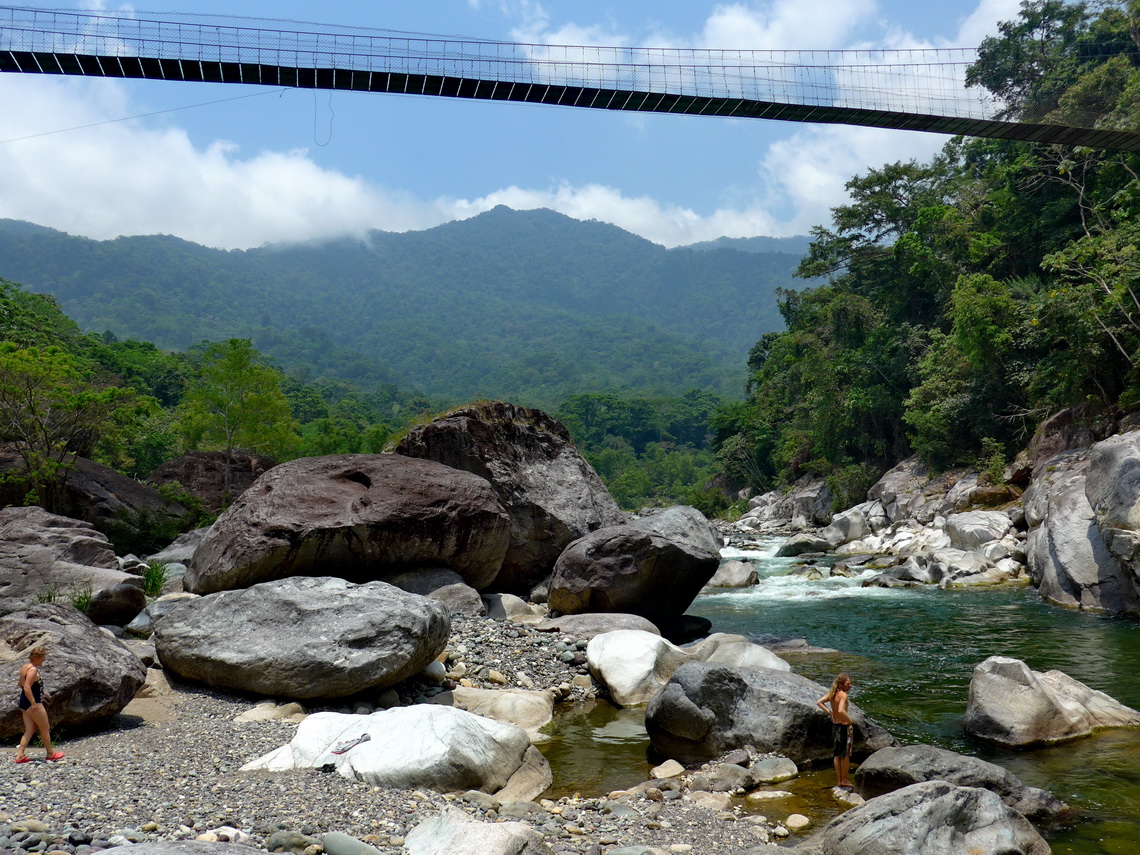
[793,781,1051,855]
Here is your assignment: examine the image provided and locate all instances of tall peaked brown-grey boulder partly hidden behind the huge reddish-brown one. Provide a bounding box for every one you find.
[396,401,625,594]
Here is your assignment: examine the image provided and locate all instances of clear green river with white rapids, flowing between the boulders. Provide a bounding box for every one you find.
[546,539,1140,855]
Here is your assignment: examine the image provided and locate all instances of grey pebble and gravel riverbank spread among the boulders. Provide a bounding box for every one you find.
[0,619,811,855]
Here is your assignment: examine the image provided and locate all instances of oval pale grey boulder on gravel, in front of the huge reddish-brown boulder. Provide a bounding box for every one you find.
[155,577,451,699]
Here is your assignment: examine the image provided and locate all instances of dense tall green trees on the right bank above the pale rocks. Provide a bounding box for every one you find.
[714,0,1140,502]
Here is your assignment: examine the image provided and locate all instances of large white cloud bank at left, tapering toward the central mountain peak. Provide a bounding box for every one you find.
[0,75,440,249]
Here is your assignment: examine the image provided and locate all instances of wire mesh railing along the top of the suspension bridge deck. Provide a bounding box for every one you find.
[0,7,1003,119]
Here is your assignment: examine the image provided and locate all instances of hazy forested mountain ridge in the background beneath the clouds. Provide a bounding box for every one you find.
[0,207,803,406]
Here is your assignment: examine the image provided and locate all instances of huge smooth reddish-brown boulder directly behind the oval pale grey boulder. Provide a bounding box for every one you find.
[184,454,511,594]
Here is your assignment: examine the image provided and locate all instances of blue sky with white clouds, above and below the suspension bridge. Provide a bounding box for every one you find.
[0,0,1019,250]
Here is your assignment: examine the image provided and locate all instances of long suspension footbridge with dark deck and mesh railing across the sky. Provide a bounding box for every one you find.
[0,6,1140,152]
